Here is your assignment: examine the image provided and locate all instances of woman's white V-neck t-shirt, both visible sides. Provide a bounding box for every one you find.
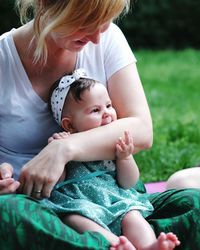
[0,23,136,178]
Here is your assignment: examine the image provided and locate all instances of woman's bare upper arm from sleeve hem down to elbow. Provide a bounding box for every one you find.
[108,63,153,152]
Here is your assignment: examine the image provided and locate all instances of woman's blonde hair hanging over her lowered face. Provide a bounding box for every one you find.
[16,0,130,63]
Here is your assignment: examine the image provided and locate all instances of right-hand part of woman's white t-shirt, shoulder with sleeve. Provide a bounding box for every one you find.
[77,23,136,82]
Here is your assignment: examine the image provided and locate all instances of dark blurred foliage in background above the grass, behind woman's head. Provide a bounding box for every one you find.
[0,0,200,50]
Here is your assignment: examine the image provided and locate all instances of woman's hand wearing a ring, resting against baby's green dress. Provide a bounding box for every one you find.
[19,139,71,199]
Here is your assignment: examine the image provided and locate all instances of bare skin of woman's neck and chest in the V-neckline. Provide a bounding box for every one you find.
[13,22,77,100]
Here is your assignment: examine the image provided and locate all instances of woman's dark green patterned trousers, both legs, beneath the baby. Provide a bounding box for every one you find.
[0,189,200,250]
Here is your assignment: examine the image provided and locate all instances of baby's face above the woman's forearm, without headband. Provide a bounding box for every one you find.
[65,83,117,132]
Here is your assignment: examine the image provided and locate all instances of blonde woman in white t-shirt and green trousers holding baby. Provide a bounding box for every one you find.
[0,0,200,250]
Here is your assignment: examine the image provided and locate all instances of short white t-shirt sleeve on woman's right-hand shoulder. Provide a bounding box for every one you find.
[103,23,136,79]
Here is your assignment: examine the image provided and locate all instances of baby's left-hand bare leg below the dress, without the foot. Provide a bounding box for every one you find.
[63,214,119,244]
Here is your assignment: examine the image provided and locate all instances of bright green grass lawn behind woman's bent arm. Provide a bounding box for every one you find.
[135,49,200,182]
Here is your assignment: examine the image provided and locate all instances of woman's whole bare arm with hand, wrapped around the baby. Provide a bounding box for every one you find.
[20,63,153,197]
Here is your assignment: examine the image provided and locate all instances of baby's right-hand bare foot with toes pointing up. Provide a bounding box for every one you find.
[155,233,180,250]
